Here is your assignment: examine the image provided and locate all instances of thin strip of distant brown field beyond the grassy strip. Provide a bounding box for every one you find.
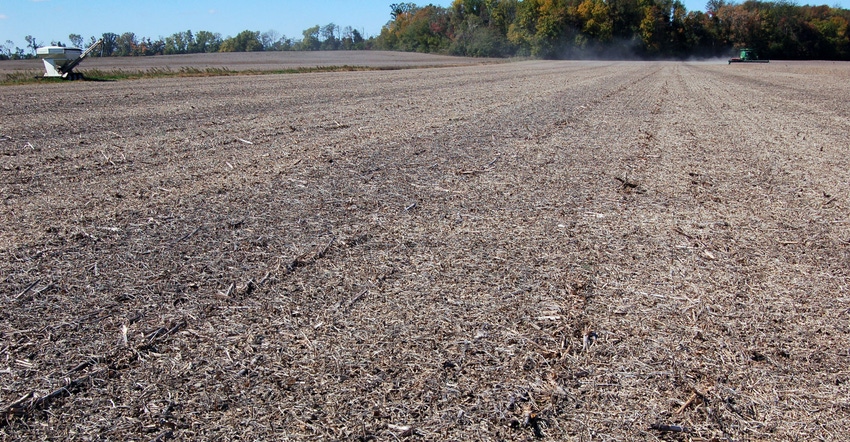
[0,51,497,79]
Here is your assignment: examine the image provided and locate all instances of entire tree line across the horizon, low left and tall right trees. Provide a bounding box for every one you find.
[0,0,850,60]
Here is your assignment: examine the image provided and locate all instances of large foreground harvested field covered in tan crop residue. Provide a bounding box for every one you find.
[0,57,850,440]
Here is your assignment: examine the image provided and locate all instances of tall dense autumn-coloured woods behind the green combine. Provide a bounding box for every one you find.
[376,0,850,60]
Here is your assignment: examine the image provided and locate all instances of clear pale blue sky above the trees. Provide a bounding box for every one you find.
[0,0,850,47]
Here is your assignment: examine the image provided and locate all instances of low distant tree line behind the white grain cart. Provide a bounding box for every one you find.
[0,23,375,60]
